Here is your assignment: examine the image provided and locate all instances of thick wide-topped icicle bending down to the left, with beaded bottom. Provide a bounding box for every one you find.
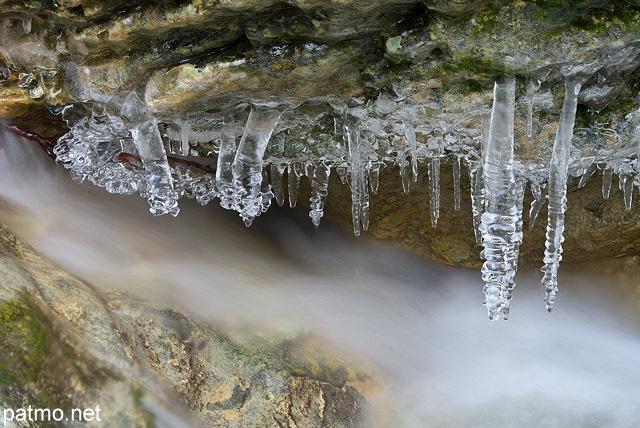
[231,106,282,226]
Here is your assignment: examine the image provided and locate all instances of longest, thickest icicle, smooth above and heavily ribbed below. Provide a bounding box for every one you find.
[480,76,522,320]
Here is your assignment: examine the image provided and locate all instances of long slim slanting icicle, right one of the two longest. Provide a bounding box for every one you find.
[542,80,582,312]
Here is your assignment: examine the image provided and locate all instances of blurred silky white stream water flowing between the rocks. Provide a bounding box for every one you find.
[0,129,640,427]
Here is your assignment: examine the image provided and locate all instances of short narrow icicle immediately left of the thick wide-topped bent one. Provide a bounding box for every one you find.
[216,114,237,210]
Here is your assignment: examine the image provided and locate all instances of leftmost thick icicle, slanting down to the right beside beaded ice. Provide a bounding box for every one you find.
[121,90,180,216]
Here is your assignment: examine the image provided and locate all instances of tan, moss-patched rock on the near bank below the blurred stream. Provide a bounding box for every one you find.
[0,224,371,428]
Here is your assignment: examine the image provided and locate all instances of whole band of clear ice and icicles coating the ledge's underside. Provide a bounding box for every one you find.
[11,56,640,319]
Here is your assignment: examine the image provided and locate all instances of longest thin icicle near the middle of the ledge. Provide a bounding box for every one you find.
[345,113,369,236]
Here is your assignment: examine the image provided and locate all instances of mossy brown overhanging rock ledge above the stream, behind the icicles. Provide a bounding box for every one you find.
[0,0,640,265]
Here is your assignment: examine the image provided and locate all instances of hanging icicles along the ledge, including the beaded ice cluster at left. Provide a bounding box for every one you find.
[55,76,640,320]
